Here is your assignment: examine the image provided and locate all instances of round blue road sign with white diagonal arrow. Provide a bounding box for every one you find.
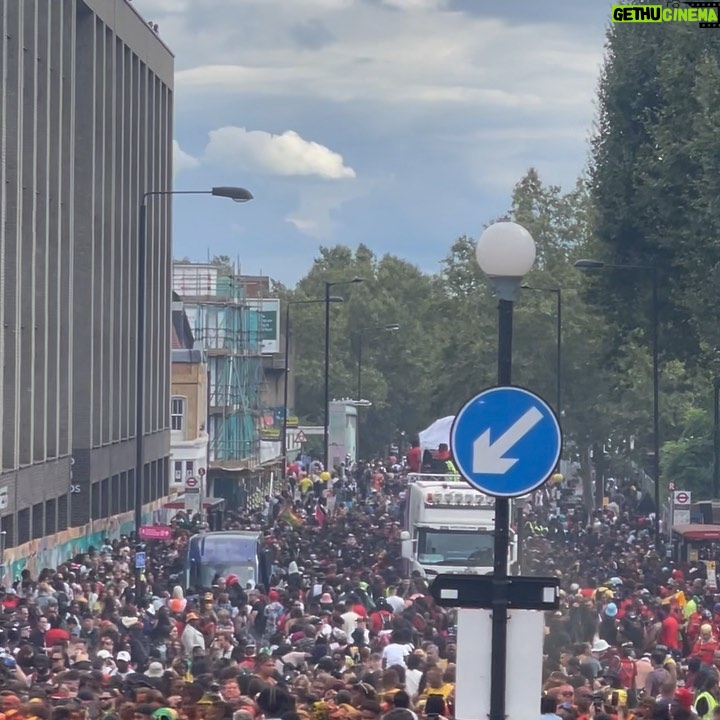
[450,386,562,497]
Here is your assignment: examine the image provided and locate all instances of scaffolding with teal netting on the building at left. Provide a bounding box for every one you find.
[173,263,265,469]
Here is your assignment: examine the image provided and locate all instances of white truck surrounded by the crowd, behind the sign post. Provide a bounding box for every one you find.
[400,473,517,579]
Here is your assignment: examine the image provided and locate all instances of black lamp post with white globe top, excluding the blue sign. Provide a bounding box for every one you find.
[475,222,535,720]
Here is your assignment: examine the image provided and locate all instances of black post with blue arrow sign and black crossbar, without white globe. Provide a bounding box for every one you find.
[450,388,562,720]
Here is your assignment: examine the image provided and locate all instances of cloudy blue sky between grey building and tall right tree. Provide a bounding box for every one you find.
[134,0,610,284]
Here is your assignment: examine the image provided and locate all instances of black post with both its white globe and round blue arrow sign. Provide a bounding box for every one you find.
[450,217,548,720]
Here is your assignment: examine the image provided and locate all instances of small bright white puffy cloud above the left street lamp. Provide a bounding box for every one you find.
[204,127,355,180]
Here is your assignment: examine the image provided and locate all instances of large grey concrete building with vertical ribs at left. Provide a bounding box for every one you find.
[0,0,174,557]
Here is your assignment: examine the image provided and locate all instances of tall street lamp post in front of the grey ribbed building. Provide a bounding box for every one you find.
[134,187,253,540]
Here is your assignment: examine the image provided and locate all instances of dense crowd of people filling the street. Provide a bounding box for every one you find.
[0,448,720,720]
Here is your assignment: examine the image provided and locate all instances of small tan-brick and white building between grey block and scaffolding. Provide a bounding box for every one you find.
[170,293,208,492]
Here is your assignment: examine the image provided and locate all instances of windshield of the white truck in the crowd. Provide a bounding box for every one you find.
[417,528,494,567]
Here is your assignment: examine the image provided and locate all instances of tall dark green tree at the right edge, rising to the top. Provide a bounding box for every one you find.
[589,23,720,364]
